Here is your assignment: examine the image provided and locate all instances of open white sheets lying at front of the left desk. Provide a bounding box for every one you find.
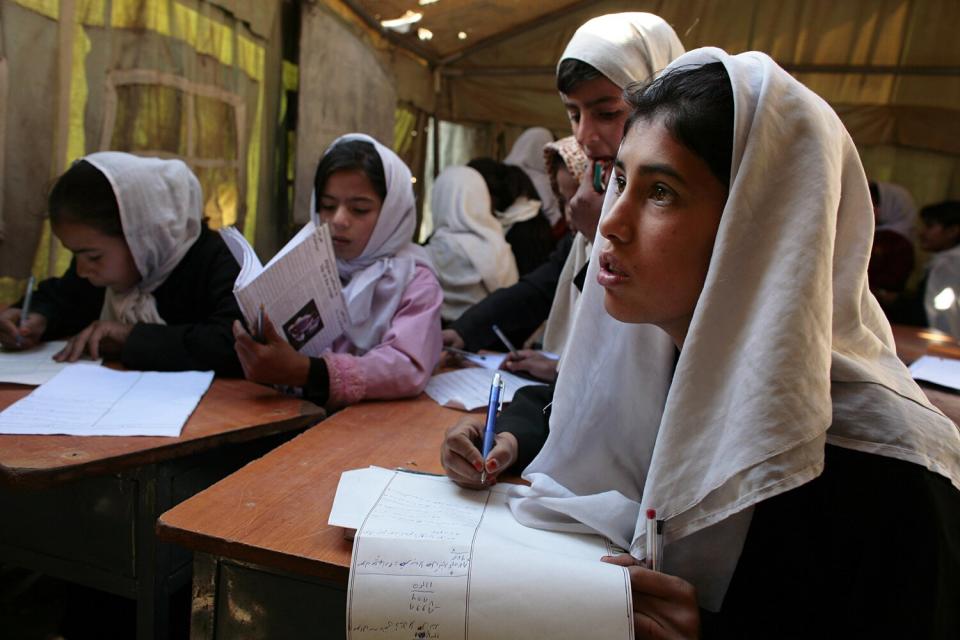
[0,364,213,437]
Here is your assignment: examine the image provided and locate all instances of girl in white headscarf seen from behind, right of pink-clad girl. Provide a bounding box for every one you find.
[426,167,517,321]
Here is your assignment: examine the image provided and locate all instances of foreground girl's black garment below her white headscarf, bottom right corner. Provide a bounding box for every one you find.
[704,445,960,638]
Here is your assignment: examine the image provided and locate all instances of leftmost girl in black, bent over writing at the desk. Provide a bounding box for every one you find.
[0,151,242,376]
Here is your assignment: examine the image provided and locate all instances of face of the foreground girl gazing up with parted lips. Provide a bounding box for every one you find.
[597,118,727,346]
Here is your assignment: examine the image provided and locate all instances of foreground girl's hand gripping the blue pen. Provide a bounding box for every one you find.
[440,415,519,489]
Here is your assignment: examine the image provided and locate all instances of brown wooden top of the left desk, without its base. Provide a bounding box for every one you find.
[0,378,324,488]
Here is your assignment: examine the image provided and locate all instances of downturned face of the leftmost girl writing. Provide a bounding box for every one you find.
[53,221,140,293]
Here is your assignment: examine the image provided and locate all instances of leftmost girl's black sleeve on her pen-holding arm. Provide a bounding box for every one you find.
[25,260,104,340]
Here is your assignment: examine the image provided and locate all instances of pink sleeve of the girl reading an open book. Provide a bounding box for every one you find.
[323,266,443,408]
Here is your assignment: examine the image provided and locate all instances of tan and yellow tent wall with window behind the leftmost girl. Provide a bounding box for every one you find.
[0,0,280,301]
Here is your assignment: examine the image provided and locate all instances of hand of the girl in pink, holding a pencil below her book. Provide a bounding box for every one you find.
[233,314,310,387]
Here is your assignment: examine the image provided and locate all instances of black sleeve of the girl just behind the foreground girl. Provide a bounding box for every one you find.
[450,235,573,351]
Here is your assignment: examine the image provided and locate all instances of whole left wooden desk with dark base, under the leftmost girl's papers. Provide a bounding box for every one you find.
[0,379,324,638]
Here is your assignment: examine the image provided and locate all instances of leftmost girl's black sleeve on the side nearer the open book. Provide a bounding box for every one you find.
[120,228,243,377]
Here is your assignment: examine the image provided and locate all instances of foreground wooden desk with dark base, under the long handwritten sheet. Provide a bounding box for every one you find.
[157,395,464,638]
